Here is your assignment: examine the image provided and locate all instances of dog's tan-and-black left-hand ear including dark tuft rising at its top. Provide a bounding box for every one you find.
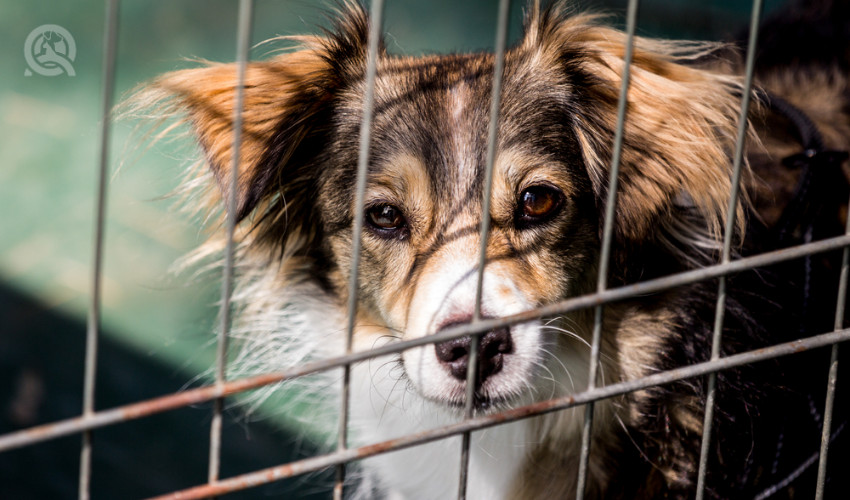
[130,3,368,226]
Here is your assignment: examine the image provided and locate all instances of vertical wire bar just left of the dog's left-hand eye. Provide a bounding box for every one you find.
[333,0,384,500]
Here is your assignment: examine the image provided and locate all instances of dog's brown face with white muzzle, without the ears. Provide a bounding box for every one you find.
[317,53,597,405]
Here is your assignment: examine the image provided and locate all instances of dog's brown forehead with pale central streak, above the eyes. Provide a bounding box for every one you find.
[362,50,568,201]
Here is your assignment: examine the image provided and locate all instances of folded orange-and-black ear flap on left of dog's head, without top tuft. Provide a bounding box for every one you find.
[142,49,330,220]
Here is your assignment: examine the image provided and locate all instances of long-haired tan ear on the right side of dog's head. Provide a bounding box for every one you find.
[522,4,746,262]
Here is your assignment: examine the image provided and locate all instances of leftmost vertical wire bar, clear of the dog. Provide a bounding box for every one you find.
[78,0,118,500]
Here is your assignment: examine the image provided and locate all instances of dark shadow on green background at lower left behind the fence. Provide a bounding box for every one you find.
[0,285,332,499]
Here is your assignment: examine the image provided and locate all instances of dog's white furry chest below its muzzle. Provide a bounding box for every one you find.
[351,358,530,499]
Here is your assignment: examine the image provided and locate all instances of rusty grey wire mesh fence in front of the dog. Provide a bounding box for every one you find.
[0,0,850,498]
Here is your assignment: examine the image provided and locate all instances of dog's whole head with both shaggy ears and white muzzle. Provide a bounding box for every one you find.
[139,1,740,407]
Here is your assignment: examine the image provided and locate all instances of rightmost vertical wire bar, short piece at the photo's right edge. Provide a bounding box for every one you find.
[815,196,850,500]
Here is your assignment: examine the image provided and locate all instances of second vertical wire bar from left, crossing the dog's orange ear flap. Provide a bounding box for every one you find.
[207,0,254,483]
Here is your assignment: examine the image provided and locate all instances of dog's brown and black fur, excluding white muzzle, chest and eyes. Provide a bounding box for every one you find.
[127,3,850,498]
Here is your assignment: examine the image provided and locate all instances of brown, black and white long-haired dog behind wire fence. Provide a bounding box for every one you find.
[126,2,850,499]
